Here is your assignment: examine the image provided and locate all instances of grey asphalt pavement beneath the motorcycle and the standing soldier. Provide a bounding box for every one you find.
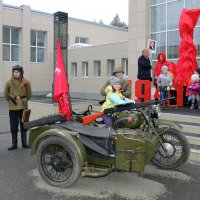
[0,96,200,200]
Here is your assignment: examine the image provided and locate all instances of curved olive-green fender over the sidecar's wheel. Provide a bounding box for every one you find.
[31,129,87,166]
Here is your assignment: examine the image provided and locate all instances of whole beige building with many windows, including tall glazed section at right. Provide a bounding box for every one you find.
[0,0,200,99]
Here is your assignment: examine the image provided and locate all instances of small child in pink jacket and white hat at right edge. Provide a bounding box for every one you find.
[189,74,200,109]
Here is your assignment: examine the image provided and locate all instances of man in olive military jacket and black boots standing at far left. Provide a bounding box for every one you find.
[4,65,32,150]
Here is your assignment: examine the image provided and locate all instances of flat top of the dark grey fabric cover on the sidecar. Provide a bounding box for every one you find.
[60,121,110,138]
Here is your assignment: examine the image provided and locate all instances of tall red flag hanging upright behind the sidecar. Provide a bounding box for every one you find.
[54,40,72,120]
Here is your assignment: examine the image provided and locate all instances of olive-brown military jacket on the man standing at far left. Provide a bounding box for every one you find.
[4,76,32,110]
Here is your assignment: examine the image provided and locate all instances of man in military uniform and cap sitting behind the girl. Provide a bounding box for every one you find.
[101,67,131,98]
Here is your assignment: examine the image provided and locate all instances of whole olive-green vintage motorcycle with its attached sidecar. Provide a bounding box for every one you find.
[24,102,190,188]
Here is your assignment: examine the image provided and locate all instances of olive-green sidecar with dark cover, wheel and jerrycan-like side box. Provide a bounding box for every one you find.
[29,111,158,188]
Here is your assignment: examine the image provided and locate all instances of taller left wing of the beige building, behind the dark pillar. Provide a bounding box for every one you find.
[0,0,128,96]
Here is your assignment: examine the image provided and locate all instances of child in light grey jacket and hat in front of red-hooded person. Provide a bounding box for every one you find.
[157,65,172,109]
